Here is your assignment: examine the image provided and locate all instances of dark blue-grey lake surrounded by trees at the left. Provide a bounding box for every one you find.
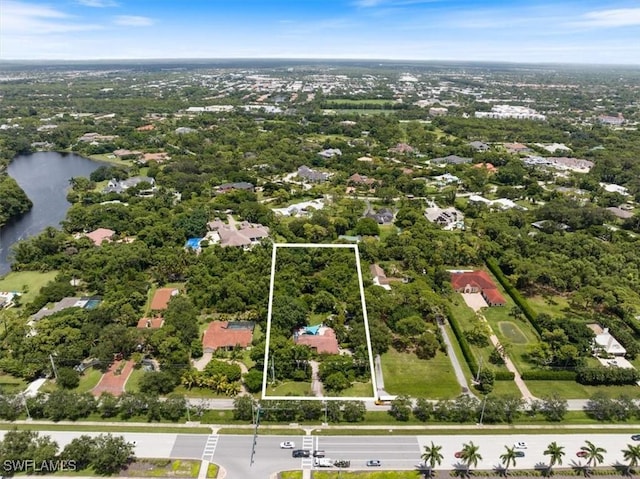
[0,151,104,276]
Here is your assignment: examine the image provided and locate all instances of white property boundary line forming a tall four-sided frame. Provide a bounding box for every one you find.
[262,243,378,401]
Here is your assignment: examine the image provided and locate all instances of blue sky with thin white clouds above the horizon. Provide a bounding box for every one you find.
[0,0,640,65]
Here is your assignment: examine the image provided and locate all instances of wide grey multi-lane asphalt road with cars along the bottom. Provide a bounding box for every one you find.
[0,431,638,478]
